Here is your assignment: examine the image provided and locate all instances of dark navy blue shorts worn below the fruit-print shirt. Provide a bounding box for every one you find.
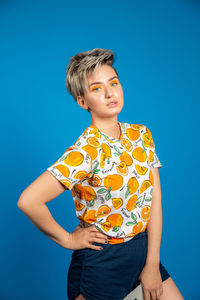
[67,230,170,300]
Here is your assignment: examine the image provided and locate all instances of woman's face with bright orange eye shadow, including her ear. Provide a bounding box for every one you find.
[77,65,124,119]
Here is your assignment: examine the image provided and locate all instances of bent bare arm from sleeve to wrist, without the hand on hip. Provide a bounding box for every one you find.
[17,171,69,248]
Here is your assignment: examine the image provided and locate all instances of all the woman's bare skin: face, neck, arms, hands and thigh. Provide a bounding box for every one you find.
[17,65,183,300]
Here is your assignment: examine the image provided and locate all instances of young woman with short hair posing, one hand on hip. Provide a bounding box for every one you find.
[18,48,183,300]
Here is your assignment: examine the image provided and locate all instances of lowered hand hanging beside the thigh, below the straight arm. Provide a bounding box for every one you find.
[138,265,163,300]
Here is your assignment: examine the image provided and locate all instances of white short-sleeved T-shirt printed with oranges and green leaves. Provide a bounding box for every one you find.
[47,122,162,244]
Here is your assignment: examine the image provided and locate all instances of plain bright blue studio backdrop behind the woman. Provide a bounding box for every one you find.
[0,0,200,300]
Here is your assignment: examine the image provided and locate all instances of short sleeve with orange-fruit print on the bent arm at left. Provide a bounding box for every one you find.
[47,145,92,190]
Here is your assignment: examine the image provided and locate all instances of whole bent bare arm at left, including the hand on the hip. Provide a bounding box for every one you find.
[17,170,107,250]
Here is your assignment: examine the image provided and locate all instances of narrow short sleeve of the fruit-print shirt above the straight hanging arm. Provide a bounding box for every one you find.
[146,127,163,169]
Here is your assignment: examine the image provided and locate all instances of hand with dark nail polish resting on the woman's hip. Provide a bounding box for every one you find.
[66,224,108,250]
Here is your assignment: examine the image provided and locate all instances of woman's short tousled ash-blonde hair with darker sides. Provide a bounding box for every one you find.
[66,48,118,111]
